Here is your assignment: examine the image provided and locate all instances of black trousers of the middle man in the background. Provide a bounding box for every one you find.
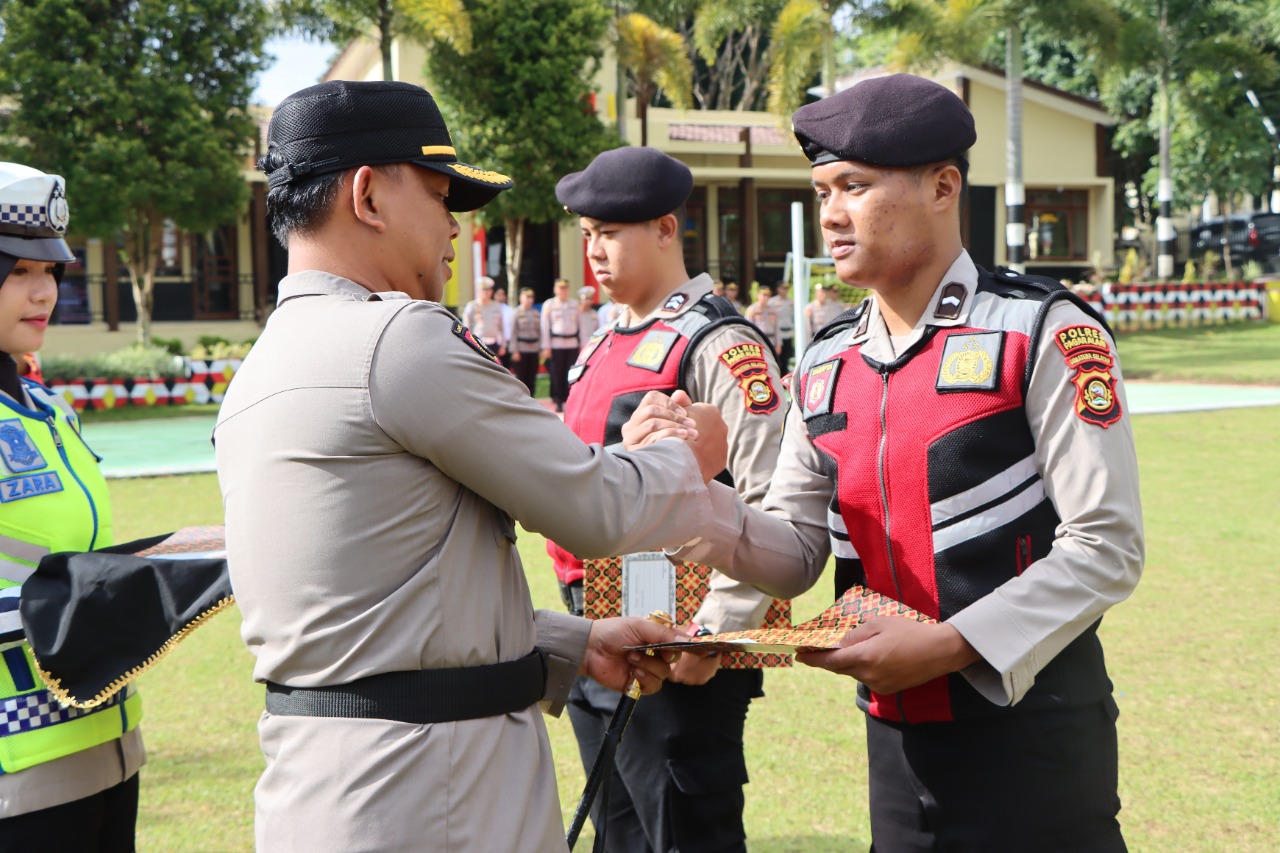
[568,670,764,853]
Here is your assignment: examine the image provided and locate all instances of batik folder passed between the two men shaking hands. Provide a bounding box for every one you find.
[636,587,937,654]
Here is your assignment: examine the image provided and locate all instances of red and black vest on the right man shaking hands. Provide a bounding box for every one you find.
[792,269,1119,722]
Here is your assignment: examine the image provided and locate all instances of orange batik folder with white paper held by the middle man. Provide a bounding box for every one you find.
[582,557,791,670]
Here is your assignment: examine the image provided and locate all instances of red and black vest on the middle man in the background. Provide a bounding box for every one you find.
[548,293,778,584]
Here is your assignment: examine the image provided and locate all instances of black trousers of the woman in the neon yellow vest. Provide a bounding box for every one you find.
[0,774,138,853]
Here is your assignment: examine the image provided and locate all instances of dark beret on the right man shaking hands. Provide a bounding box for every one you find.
[791,74,978,167]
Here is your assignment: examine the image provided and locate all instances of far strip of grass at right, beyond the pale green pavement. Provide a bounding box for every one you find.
[1116,323,1280,386]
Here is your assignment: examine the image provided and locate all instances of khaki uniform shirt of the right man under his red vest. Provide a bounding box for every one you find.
[676,252,1144,704]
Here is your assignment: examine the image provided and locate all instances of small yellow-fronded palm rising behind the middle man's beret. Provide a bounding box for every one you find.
[613,12,694,145]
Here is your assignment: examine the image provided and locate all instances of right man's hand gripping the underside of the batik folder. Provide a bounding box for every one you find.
[796,616,979,693]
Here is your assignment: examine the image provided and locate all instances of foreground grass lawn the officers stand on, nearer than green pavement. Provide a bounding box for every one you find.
[111,404,1280,853]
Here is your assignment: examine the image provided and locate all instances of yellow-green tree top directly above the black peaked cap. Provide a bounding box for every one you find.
[275,0,471,79]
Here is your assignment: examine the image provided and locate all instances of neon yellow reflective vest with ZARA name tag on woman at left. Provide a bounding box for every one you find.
[0,382,142,774]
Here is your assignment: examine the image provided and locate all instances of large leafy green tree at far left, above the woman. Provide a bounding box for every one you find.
[0,0,268,343]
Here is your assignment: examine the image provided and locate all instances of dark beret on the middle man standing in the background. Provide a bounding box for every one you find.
[556,147,694,222]
